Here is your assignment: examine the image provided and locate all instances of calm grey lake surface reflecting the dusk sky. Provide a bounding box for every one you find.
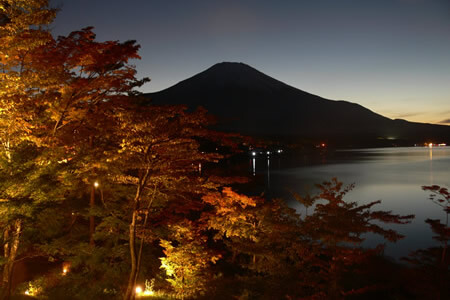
[248,147,450,259]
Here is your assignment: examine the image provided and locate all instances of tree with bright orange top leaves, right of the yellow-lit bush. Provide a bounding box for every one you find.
[202,187,314,299]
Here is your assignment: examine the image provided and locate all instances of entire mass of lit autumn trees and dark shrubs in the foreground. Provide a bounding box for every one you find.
[0,0,450,300]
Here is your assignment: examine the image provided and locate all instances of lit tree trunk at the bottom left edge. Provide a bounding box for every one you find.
[2,219,22,300]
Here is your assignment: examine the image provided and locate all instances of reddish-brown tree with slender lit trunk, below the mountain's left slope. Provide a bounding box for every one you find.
[111,106,234,299]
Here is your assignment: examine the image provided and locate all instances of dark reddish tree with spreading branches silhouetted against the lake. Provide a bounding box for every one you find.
[303,178,414,298]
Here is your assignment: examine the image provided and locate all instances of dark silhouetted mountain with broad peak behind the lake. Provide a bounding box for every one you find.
[146,62,450,144]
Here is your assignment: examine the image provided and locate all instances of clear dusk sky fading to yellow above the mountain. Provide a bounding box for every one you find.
[51,0,450,124]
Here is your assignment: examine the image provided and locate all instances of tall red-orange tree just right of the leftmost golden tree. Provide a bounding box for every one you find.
[35,28,160,298]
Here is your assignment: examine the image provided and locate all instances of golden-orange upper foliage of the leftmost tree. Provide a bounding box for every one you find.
[0,0,59,147]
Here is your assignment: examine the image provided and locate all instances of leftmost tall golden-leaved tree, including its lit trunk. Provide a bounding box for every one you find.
[0,0,56,298]
